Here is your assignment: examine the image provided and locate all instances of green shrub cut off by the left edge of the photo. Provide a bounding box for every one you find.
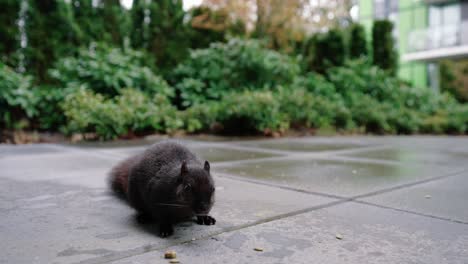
[0,62,37,128]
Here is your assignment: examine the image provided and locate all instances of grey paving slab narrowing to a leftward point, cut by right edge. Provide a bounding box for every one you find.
[362,172,468,223]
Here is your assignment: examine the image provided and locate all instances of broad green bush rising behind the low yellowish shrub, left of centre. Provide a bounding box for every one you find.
[50,45,172,96]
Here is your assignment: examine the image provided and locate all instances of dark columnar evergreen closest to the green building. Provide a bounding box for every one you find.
[372,20,398,75]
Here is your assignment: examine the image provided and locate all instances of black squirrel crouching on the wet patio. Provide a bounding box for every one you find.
[109,141,216,237]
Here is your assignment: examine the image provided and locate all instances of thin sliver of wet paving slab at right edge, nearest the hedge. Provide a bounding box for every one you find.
[342,145,468,167]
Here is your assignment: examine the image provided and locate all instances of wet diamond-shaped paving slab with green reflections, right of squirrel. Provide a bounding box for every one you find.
[219,159,462,197]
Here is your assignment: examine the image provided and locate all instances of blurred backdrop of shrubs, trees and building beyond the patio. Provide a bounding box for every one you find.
[0,0,468,143]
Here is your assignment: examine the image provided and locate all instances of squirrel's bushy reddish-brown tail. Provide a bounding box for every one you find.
[109,157,137,200]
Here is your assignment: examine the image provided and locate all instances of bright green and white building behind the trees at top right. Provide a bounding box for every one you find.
[358,0,468,90]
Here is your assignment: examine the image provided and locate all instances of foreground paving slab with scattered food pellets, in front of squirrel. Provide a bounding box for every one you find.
[112,202,468,264]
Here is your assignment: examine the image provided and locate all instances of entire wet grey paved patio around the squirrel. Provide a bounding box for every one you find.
[0,137,468,263]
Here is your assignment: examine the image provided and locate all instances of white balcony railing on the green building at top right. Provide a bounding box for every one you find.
[408,21,468,52]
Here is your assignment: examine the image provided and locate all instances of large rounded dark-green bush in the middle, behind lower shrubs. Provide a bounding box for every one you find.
[174,39,299,107]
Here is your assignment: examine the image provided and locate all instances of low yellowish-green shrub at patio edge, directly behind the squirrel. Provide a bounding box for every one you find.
[62,87,182,139]
